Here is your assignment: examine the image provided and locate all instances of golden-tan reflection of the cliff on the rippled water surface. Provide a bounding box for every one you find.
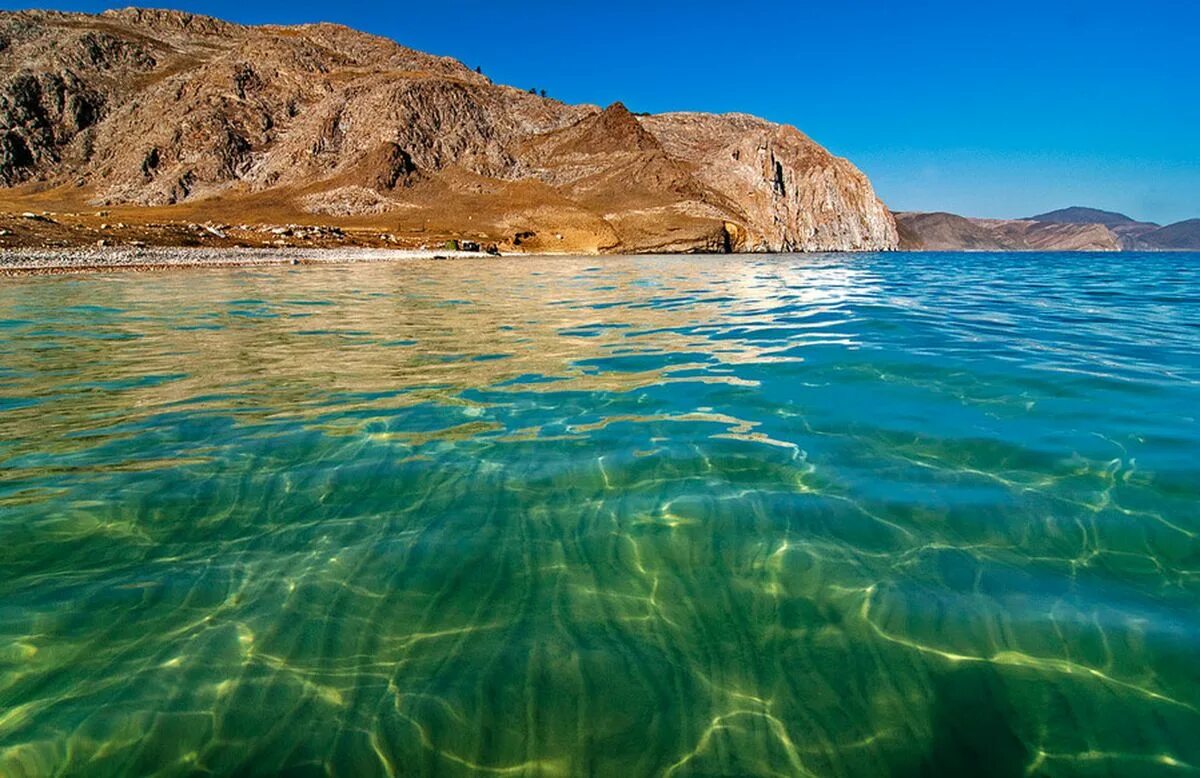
[0,258,871,444]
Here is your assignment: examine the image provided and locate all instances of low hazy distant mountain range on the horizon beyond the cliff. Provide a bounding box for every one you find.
[894,205,1200,251]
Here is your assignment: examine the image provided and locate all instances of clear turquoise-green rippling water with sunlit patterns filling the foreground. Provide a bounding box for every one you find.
[0,255,1200,777]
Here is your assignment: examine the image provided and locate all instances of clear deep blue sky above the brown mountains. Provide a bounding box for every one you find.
[11,0,1200,222]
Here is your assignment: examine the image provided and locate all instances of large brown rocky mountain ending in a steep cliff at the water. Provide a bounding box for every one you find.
[0,8,898,251]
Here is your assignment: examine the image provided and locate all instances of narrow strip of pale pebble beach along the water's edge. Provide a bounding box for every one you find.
[0,246,506,275]
